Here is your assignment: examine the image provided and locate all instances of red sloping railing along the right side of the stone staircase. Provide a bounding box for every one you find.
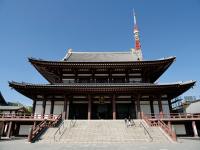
[143,115,177,141]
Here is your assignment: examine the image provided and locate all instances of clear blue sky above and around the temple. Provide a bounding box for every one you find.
[0,0,200,105]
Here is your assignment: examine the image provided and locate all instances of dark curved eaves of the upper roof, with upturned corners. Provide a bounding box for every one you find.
[29,57,176,83]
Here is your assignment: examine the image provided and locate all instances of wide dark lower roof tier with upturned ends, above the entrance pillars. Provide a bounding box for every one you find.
[9,81,196,99]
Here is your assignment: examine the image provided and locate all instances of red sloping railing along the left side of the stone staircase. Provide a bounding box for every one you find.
[28,114,62,142]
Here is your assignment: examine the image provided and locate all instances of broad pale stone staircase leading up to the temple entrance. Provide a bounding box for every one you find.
[39,120,169,143]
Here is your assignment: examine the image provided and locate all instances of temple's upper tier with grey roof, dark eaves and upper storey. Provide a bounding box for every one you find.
[29,51,175,83]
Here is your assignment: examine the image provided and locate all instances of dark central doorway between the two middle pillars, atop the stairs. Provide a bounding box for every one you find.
[92,104,112,119]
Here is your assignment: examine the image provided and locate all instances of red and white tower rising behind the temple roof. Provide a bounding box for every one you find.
[133,9,143,61]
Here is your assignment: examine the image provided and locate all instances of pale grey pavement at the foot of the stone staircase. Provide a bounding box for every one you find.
[0,139,200,150]
